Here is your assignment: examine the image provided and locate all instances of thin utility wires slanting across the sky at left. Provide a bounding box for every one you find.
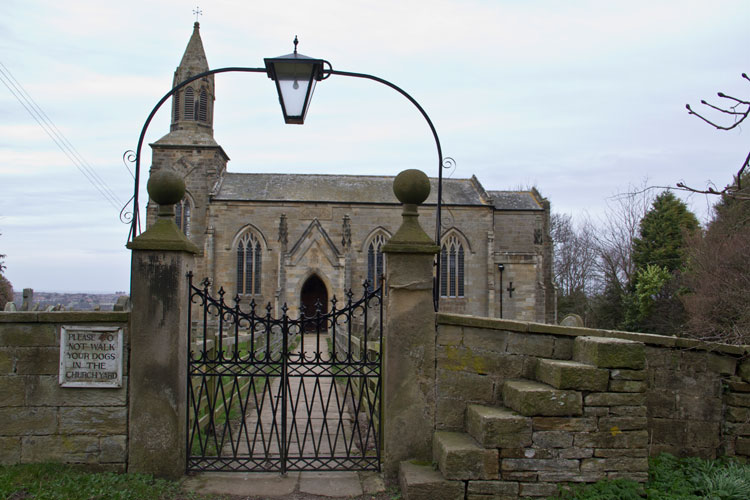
[0,62,122,212]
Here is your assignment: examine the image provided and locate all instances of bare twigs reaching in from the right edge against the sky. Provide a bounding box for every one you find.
[688,73,750,200]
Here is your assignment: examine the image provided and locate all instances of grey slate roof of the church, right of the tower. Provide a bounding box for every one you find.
[213,172,542,210]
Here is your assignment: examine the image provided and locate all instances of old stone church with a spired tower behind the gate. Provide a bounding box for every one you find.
[147,22,556,323]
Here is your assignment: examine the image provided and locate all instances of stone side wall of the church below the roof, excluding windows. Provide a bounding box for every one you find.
[200,197,546,322]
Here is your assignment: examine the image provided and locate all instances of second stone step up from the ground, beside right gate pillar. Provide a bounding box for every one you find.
[432,431,499,481]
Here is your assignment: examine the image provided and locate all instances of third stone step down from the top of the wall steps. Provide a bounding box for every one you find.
[503,380,583,417]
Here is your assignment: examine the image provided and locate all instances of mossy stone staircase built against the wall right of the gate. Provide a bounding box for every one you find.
[399,337,648,500]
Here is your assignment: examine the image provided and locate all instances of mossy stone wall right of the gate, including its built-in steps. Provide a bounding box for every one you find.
[408,313,750,499]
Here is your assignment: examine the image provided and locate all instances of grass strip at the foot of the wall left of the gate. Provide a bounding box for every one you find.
[0,464,207,500]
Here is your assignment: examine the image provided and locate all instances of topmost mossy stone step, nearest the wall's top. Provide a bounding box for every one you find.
[573,337,646,370]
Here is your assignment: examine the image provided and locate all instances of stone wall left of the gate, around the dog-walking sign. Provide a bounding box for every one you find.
[0,312,129,471]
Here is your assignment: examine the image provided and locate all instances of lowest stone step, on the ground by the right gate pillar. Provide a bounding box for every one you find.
[398,462,464,500]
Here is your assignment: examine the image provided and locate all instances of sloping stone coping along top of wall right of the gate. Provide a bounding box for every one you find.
[437,313,750,356]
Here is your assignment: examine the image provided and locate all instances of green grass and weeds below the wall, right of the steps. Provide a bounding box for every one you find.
[559,453,750,500]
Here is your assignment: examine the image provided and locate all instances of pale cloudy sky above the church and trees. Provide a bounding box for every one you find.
[0,0,750,292]
